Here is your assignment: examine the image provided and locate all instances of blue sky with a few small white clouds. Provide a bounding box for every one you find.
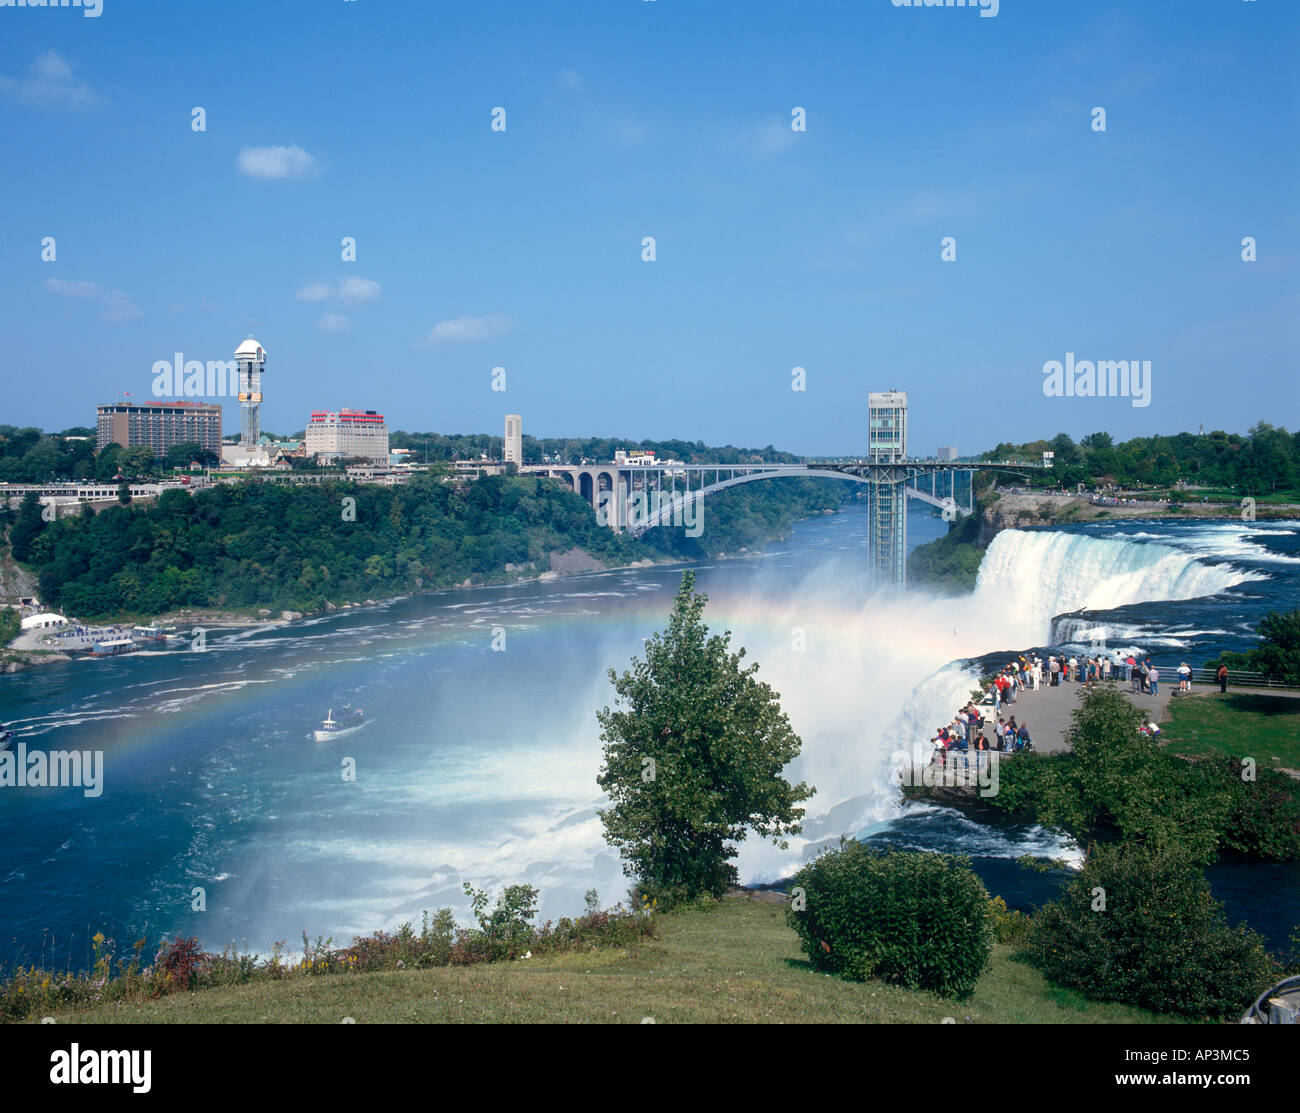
[0,0,1300,454]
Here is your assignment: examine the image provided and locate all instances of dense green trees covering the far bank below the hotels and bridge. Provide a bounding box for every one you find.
[0,475,842,620]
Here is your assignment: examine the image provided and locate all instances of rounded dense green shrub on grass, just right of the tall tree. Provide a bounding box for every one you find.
[787,843,993,999]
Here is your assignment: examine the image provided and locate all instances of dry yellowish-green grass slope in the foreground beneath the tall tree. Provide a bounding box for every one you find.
[32,893,1173,1023]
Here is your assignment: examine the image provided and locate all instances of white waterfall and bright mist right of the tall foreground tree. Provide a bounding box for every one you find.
[740,527,1261,882]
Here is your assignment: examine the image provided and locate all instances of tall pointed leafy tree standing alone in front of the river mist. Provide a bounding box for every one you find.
[597,572,813,904]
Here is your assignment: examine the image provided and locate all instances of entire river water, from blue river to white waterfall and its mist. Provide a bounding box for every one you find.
[0,504,1300,966]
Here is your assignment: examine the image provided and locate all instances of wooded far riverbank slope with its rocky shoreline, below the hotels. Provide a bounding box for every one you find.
[7,477,844,671]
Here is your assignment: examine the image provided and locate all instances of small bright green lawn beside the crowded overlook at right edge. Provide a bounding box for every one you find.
[1161,692,1300,770]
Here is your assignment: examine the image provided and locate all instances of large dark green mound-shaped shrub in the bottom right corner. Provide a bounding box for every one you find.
[1027,843,1278,1019]
